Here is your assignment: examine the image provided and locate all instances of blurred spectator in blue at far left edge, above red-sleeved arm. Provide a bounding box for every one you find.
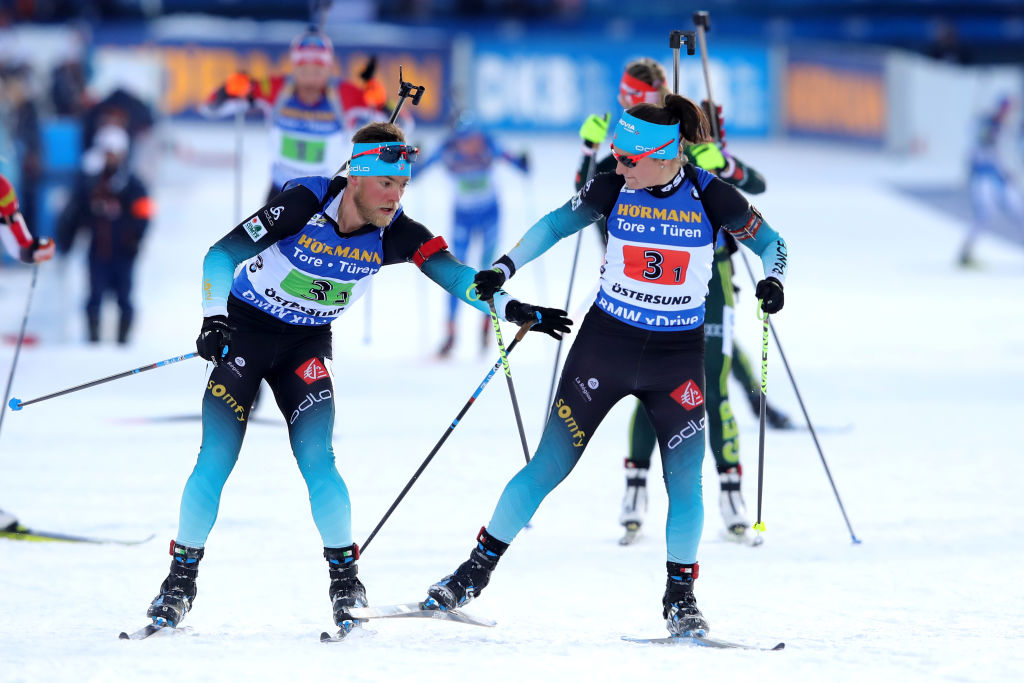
[0,65,42,235]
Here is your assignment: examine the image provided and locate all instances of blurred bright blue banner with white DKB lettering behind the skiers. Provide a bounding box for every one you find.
[469,37,778,136]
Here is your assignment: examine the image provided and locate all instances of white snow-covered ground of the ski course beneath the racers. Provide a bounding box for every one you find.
[0,125,1024,682]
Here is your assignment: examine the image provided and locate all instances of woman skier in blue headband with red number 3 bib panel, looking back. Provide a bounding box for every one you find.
[424,95,786,635]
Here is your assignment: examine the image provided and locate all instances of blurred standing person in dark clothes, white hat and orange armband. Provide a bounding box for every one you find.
[57,124,153,344]
